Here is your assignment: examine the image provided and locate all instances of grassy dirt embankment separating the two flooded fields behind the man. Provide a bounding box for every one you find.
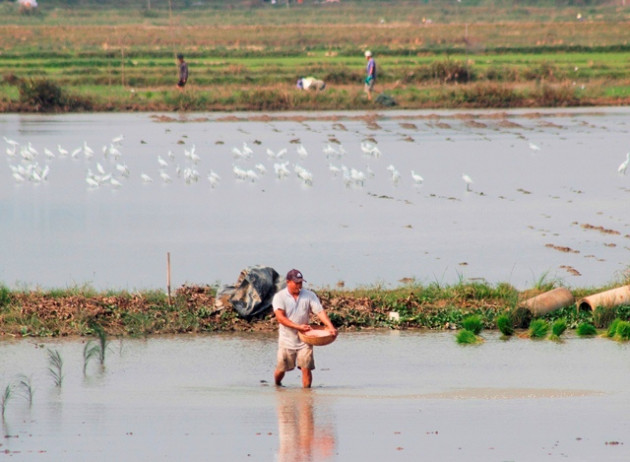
[0,286,508,337]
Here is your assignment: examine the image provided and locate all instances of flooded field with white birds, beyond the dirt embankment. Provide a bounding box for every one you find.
[0,108,630,290]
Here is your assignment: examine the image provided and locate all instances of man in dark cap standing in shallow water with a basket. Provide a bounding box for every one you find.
[272,269,337,388]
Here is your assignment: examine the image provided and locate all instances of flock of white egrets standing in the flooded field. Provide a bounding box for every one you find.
[3,131,630,191]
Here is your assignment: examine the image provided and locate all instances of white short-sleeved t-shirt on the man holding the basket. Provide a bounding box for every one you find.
[271,287,324,350]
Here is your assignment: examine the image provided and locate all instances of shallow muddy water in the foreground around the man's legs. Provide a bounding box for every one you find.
[0,332,630,461]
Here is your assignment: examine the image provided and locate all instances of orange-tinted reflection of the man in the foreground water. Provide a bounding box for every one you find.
[277,388,335,462]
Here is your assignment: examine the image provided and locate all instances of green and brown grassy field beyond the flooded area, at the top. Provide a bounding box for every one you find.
[0,0,630,112]
